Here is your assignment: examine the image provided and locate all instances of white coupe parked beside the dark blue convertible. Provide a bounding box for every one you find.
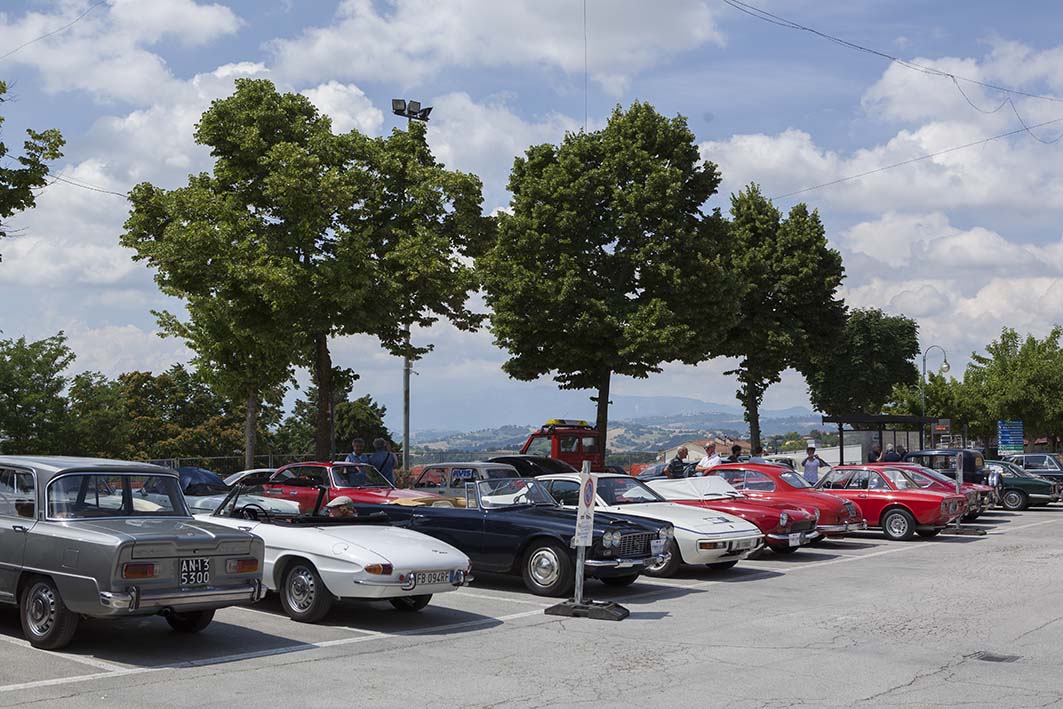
[536,473,764,576]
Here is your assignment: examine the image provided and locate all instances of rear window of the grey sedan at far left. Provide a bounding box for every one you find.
[48,473,188,520]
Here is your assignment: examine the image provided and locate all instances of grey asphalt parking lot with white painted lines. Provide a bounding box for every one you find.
[0,506,1063,707]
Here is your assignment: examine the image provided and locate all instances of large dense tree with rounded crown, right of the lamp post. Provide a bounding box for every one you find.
[477,102,737,432]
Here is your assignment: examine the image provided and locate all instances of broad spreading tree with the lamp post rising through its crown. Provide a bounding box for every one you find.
[122,79,489,458]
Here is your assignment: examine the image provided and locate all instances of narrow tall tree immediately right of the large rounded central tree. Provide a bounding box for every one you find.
[719,185,845,446]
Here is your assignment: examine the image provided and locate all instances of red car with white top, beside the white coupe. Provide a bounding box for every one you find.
[646,476,819,554]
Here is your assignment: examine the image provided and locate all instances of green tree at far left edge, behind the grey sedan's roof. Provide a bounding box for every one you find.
[0,332,74,454]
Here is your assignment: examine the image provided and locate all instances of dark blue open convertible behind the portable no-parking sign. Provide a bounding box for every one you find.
[356,477,673,596]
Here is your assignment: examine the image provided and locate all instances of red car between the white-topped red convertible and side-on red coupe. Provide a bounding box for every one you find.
[708,462,867,541]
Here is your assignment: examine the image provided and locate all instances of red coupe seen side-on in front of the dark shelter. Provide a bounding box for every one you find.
[816,466,967,540]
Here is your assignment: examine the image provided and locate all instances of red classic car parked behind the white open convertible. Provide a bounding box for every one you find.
[263,462,439,511]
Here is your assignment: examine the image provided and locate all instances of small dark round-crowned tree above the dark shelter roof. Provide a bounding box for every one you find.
[805,308,919,416]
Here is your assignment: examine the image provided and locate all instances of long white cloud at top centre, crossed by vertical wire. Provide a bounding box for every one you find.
[272,0,723,92]
